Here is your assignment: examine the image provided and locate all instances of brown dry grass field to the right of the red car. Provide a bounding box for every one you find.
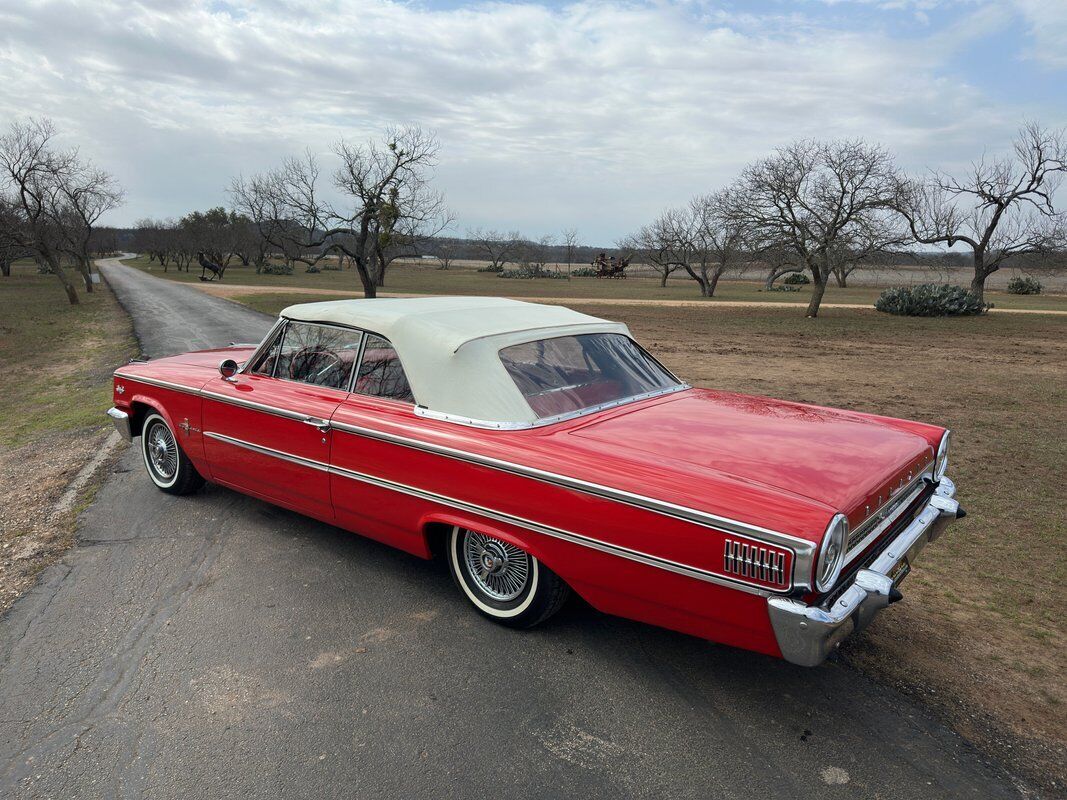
[220,276,1067,790]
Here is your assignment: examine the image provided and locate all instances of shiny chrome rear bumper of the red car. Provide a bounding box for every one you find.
[767,478,962,667]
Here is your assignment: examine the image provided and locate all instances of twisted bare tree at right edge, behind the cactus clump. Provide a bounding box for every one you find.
[897,123,1067,298]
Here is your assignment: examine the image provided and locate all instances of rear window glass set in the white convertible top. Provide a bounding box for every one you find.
[500,334,678,419]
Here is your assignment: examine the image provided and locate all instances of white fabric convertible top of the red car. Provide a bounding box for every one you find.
[282,297,630,427]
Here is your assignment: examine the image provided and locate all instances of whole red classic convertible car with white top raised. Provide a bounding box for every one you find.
[108,298,964,666]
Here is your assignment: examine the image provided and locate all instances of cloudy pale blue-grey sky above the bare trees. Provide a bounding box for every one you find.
[0,0,1067,244]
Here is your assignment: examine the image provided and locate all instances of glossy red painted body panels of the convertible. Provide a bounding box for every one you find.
[115,348,943,655]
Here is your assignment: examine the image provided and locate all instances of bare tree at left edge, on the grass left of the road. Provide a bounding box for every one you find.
[0,119,121,304]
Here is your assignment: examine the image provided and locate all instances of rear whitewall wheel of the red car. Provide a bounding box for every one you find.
[448,527,570,628]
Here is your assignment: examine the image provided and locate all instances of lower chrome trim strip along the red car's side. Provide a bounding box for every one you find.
[204,431,784,597]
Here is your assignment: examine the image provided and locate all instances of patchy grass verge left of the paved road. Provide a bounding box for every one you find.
[0,263,137,611]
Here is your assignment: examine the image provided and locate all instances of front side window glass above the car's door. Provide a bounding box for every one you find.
[274,322,363,389]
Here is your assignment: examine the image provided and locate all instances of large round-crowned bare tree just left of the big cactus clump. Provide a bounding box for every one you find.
[723,140,899,317]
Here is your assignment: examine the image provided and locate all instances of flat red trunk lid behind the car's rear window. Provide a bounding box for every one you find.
[569,389,939,525]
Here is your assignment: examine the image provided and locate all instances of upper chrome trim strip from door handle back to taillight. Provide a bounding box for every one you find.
[332,419,815,558]
